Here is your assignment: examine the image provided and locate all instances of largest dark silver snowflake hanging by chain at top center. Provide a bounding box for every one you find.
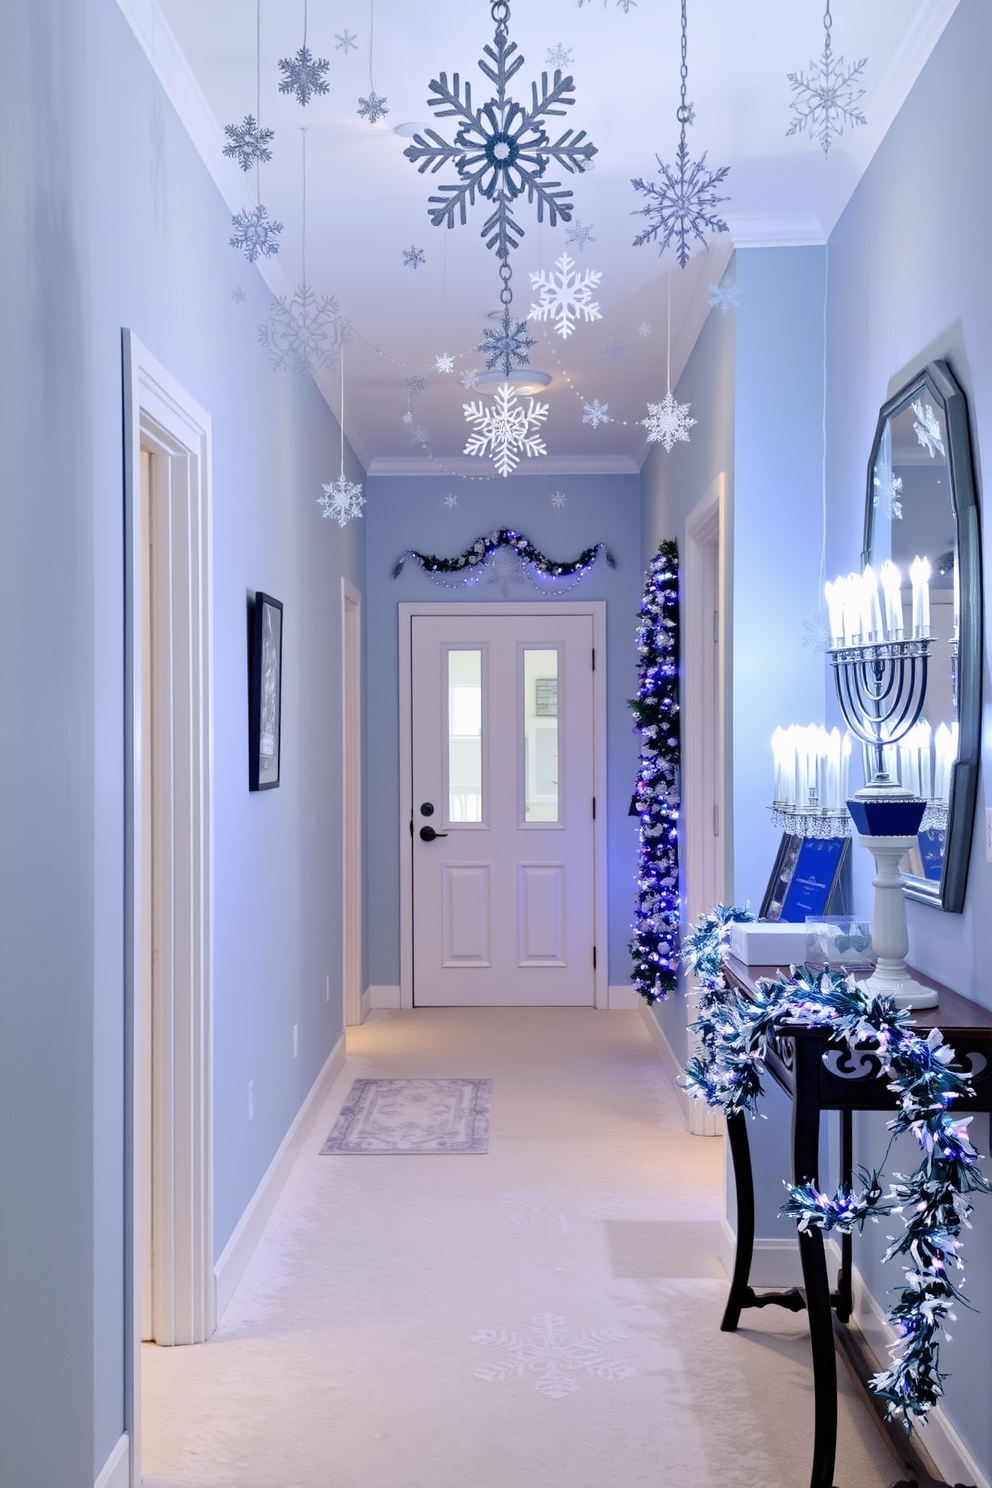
[403,21,596,259]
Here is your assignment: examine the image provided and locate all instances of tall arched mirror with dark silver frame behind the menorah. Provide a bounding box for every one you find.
[864,362,983,914]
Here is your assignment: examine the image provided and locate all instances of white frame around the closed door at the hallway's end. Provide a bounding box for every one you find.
[399,600,610,1007]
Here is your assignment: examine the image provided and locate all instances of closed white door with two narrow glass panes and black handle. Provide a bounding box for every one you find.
[410,613,595,1007]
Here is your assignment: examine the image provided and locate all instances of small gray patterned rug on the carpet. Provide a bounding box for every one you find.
[320,1080,492,1156]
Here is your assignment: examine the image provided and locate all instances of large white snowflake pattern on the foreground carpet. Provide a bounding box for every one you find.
[471,1312,637,1400]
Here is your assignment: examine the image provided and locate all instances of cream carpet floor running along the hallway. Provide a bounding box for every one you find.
[143,1009,897,1488]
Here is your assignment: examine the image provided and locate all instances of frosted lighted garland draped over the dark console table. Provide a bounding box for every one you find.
[684,905,992,1428]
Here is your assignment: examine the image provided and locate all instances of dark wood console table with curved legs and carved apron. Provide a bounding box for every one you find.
[721,957,992,1488]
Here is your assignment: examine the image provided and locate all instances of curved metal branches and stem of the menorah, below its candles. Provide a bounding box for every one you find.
[828,635,931,786]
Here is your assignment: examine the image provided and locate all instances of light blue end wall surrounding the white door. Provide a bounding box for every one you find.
[366,466,642,987]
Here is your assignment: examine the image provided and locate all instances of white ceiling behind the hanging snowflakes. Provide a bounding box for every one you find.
[119,0,956,473]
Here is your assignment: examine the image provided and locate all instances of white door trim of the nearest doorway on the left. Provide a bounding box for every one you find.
[122,330,216,1485]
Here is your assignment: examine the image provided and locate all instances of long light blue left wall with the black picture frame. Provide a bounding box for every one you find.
[0,0,364,1488]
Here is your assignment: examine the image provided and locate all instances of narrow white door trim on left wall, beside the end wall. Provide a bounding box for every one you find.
[341,579,363,1025]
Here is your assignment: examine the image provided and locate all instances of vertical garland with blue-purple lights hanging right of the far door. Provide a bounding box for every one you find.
[631,542,680,1006]
